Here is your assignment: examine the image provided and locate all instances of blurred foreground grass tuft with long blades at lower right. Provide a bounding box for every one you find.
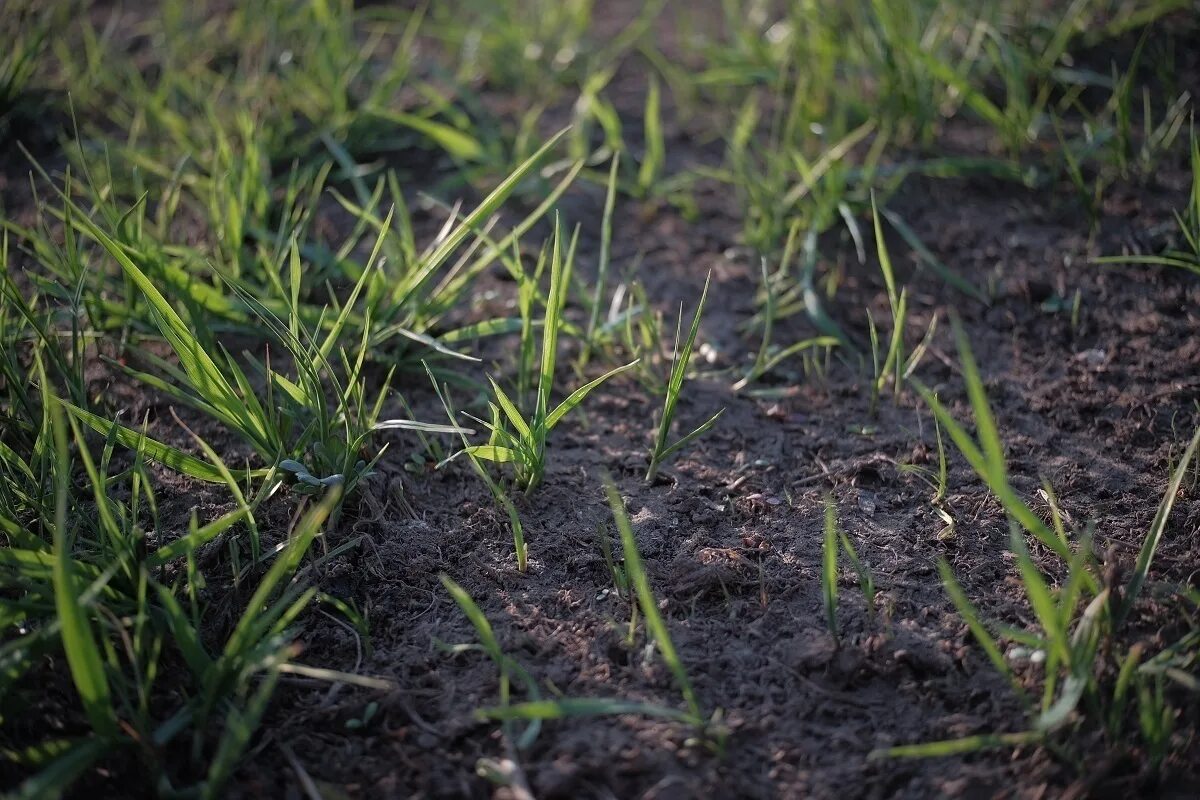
[875,326,1200,768]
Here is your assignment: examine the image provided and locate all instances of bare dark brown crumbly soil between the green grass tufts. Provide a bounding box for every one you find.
[4,1,1200,800]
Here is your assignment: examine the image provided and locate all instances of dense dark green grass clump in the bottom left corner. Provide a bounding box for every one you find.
[0,367,382,798]
